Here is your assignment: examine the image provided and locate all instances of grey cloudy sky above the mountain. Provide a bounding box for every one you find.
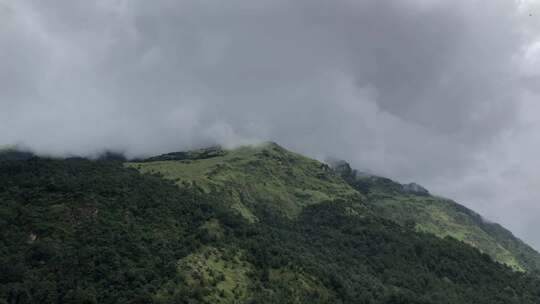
[0,0,540,249]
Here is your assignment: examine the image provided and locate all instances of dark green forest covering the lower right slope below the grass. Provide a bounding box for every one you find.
[234,203,540,303]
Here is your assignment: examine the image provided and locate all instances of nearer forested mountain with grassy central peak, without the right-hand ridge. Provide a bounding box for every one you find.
[0,143,540,304]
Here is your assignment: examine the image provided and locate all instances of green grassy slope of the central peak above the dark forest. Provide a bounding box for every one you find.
[126,143,360,222]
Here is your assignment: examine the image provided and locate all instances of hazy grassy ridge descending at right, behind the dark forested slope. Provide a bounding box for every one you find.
[333,162,540,272]
